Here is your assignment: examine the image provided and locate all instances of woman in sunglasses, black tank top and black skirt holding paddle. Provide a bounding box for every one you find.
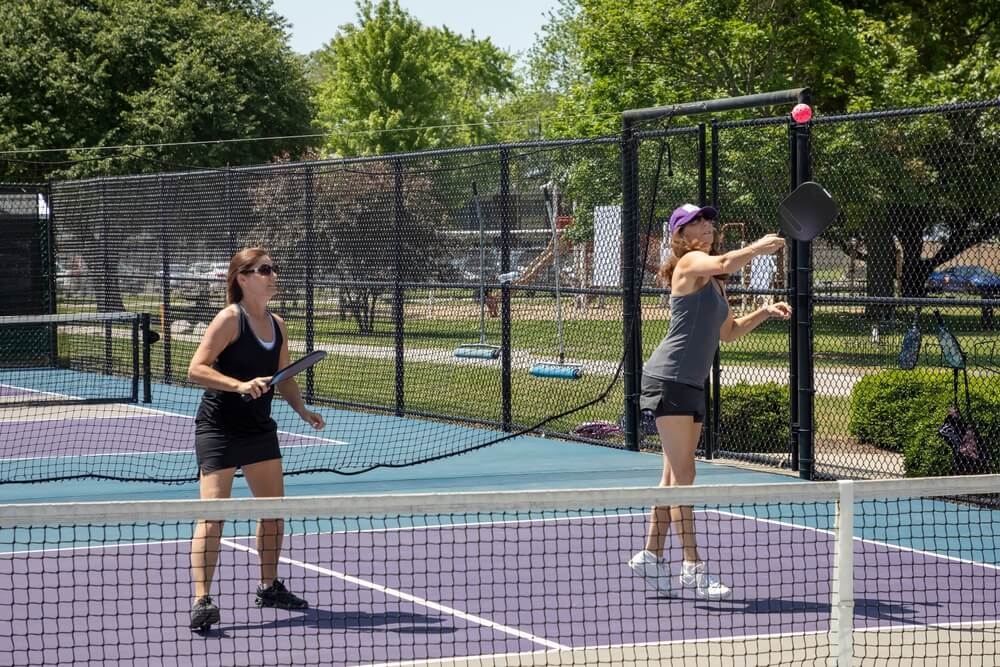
[188,248,325,629]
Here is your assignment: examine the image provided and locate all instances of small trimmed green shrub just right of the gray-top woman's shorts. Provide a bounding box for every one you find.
[719,382,791,452]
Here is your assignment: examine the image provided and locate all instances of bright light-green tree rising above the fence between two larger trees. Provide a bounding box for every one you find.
[312,0,515,156]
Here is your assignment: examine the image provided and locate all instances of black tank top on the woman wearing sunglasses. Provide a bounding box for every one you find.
[195,305,282,434]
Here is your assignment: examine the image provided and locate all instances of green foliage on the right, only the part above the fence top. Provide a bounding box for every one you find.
[527,0,1000,136]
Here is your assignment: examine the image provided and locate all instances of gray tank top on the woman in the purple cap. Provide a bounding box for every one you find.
[642,278,729,387]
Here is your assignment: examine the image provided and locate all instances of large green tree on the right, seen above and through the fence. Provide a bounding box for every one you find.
[528,0,1000,314]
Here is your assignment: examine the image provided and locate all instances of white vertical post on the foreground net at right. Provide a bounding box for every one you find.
[829,480,854,667]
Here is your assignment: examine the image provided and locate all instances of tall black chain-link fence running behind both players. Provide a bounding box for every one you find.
[5,102,1000,477]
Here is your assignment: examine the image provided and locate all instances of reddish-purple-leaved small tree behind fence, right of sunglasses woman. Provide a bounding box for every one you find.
[247,160,445,334]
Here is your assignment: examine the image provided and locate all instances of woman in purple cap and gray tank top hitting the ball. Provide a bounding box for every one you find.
[629,204,791,600]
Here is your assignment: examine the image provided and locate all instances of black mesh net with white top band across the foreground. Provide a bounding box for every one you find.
[0,476,1000,665]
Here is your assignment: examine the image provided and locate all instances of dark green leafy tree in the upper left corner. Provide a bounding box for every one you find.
[0,0,312,180]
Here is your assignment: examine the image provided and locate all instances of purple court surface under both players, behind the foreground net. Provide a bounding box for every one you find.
[0,508,1000,665]
